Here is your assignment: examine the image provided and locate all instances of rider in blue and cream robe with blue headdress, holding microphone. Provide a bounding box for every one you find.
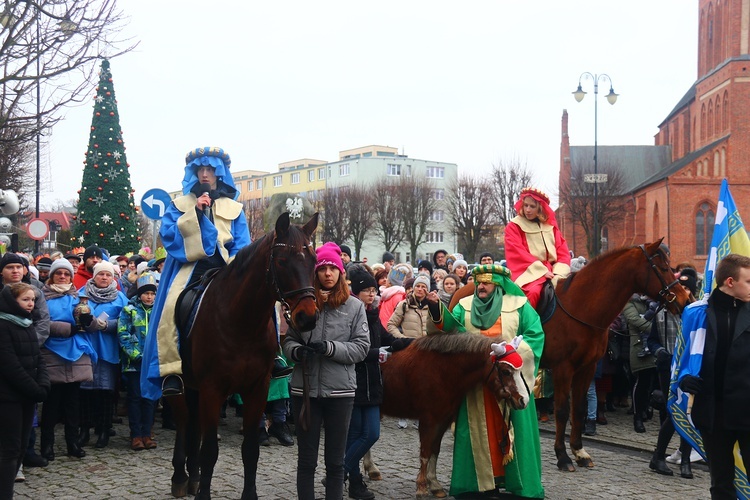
[141,147,250,399]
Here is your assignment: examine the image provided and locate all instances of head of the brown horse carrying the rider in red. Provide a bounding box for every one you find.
[638,238,693,314]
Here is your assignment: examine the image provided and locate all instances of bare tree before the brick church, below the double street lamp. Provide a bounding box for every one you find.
[559,164,625,256]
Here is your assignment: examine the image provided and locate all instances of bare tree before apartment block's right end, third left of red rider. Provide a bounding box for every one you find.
[397,177,437,263]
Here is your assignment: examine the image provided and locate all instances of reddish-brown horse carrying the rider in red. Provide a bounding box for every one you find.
[451,239,690,472]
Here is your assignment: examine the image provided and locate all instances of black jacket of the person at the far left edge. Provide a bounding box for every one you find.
[0,286,50,402]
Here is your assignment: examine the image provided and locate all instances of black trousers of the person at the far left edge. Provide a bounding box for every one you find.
[0,401,34,500]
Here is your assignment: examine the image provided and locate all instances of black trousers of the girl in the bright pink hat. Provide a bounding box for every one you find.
[292,396,354,500]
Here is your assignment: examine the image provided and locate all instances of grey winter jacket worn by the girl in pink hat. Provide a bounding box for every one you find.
[284,296,370,398]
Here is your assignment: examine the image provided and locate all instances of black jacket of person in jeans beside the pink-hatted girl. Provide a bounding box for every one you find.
[354,308,396,406]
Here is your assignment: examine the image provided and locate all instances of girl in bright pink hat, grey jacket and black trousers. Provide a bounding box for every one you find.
[284,243,370,500]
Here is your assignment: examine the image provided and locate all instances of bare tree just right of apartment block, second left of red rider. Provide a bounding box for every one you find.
[446,175,497,262]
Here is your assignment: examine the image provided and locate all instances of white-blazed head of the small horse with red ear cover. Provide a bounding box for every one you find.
[486,336,530,410]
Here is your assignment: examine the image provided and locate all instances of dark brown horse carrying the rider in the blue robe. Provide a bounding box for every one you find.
[169,213,318,499]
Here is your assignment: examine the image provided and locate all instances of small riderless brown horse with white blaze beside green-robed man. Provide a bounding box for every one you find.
[380,334,530,498]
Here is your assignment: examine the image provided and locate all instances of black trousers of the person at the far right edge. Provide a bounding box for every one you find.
[704,403,750,500]
